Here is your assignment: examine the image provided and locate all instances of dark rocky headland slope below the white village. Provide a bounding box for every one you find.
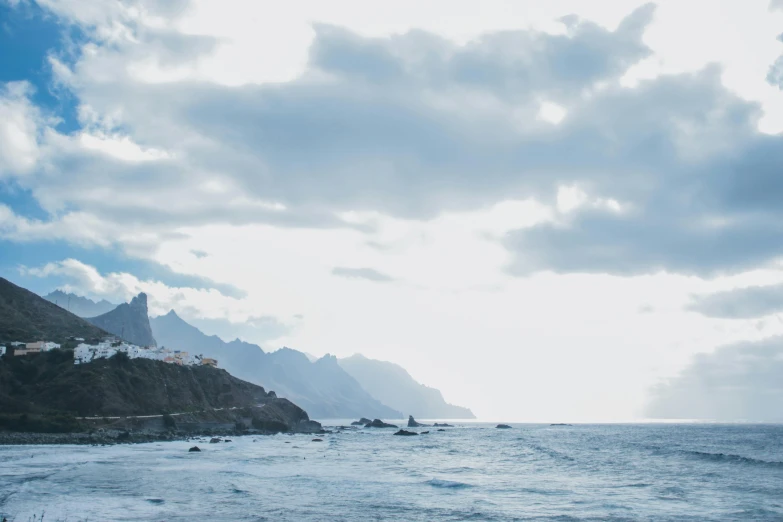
[0,350,316,429]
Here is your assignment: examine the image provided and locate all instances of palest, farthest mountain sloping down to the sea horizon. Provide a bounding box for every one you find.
[339,354,476,419]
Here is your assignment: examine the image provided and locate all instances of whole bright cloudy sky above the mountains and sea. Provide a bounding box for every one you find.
[0,0,783,422]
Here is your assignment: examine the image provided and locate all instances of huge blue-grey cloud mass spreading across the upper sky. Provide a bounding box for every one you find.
[4,2,783,275]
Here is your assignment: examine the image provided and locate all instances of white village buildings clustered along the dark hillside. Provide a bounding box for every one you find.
[0,337,218,367]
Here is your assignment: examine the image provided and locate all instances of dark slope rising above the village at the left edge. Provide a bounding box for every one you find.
[0,277,106,343]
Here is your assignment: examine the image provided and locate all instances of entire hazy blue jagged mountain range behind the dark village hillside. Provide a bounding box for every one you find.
[35,286,475,419]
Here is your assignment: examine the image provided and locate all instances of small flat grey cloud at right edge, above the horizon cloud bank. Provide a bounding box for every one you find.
[688,284,783,319]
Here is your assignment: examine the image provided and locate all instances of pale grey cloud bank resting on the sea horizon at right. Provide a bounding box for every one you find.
[647,337,783,422]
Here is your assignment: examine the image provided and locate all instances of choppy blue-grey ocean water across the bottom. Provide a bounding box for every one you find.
[0,423,783,522]
